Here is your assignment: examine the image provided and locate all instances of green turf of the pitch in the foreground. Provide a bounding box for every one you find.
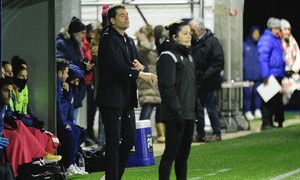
[67,120,300,180]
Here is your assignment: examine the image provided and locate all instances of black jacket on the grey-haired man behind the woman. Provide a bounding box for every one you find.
[192,29,224,90]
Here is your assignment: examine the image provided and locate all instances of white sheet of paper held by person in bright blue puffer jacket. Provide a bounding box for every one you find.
[257,75,281,102]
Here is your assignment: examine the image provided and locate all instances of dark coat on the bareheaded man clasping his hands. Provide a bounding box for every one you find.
[98,26,139,109]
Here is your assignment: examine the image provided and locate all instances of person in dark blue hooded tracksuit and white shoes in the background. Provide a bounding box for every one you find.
[243,26,262,121]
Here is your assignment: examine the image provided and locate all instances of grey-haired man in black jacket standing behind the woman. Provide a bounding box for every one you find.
[190,19,224,142]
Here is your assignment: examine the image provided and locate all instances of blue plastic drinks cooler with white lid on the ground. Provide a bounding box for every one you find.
[126,120,155,167]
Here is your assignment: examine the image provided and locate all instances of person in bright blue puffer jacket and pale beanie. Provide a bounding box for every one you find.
[258,17,285,130]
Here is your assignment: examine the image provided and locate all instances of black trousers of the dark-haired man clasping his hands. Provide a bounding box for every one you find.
[100,107,136,180]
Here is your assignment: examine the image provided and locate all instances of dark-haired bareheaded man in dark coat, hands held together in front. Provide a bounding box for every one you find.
[98,5,157,180]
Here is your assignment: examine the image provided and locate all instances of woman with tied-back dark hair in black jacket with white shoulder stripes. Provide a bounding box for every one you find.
[157,22,199,180]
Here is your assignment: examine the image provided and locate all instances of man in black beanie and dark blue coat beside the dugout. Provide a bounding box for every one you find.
[56,16,94,122]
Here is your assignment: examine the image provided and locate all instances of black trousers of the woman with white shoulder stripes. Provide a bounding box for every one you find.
[159,120,195,180]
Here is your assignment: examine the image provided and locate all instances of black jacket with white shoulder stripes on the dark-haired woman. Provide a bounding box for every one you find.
[156,40,200,121]
